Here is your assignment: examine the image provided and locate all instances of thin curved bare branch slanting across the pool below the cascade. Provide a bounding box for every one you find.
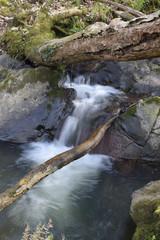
[0,110,119,211]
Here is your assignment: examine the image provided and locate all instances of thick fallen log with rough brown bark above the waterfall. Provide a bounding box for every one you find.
[29,11,160,66]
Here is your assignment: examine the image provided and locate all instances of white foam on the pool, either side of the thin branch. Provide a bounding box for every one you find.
[9,142,112,225]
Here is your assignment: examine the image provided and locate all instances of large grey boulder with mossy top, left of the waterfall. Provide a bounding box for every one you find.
[0,64,74,142]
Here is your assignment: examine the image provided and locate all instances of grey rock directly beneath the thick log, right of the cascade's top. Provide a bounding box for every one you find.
[91,58,160,96]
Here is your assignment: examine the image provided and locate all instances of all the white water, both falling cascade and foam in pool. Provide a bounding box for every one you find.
[9,77,121,231]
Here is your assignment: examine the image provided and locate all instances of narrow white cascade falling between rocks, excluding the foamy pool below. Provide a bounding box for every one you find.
[59,76,121,145]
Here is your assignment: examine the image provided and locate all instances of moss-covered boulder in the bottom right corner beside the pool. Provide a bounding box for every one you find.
[130,180,160,240]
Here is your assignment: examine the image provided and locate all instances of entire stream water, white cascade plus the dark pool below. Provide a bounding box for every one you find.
[0,76,160,240]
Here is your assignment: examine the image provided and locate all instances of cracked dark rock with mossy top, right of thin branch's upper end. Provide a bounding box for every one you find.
[94,97,160,161]
